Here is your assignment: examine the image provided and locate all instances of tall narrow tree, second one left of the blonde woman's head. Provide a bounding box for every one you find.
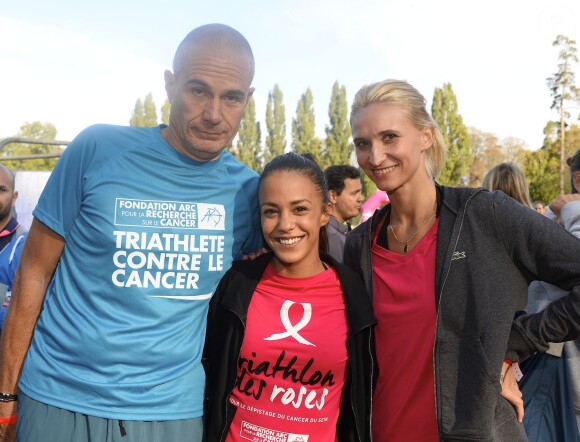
[292,88,320,161]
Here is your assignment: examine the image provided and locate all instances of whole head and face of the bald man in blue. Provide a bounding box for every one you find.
[162,24,254,162]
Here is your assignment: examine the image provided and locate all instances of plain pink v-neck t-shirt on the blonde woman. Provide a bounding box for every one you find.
[371,220,439,442]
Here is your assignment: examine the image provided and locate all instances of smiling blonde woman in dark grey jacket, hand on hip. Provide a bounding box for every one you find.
[345,80,580,442]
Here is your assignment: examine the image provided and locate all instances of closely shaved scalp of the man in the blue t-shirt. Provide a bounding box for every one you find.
[173,23,255,78]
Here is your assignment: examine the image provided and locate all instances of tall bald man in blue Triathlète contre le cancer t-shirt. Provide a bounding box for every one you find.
[0,24,262,442]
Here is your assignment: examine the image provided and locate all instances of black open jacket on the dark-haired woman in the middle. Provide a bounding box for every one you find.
[204,254,376,442]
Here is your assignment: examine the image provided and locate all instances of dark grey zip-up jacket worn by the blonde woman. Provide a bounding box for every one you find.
[344,186,580,442]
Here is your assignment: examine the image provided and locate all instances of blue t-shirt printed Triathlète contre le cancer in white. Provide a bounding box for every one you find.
[19,125,263,421]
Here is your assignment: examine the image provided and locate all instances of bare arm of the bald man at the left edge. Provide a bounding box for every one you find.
[0,220,64,441]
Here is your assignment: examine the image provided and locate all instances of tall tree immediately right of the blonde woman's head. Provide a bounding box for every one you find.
[431,83,473,186]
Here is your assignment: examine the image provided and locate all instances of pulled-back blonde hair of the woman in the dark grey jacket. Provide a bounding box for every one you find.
[350,80,447,179]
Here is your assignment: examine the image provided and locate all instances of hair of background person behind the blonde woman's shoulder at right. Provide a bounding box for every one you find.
[481,163,533,208]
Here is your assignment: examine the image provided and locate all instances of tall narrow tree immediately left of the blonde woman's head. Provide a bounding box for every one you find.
[322,81,354,168]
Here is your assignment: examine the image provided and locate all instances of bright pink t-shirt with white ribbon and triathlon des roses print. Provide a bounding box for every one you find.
[226,265,348,442]
